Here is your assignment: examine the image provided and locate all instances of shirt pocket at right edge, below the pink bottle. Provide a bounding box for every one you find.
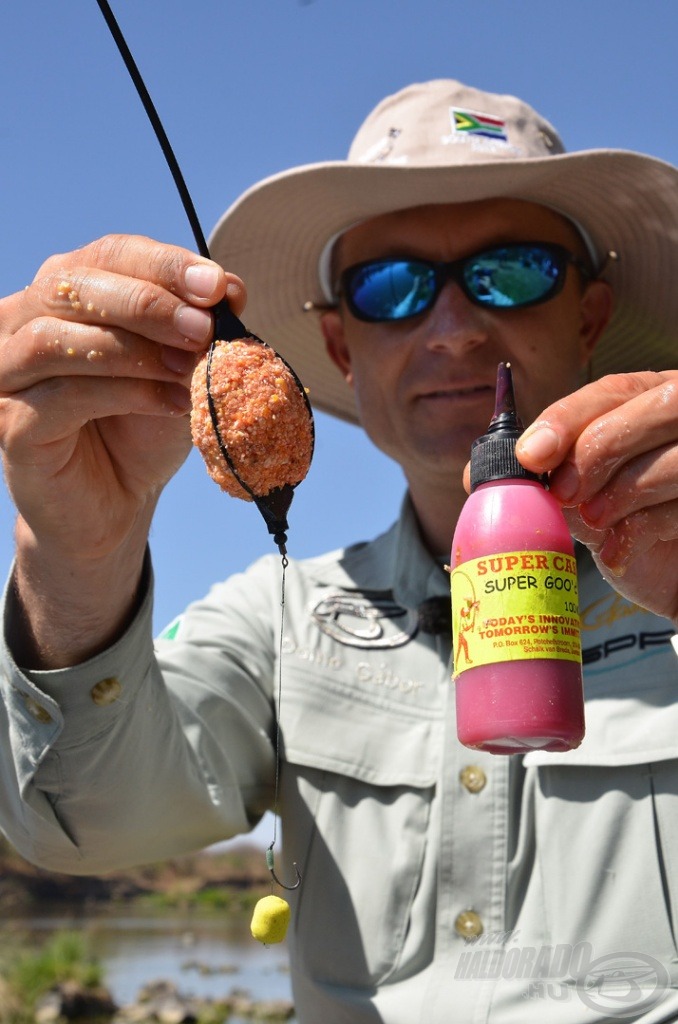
[524,682,678,962]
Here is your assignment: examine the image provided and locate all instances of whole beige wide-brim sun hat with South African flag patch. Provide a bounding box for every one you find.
[209,80,678,422]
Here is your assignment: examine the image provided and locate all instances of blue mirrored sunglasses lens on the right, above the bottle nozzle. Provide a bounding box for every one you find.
[463,246,562,308]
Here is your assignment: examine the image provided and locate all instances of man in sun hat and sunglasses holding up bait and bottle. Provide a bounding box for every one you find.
[0,82,678,1024]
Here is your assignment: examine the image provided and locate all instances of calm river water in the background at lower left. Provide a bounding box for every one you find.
[0,907,292,1006]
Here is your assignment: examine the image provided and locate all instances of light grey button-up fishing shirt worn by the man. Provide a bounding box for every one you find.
[0,493,678,1024]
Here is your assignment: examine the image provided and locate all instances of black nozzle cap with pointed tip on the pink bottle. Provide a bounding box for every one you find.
[471,362,545,490]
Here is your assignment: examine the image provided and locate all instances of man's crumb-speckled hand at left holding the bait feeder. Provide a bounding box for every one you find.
[0,236,245,668]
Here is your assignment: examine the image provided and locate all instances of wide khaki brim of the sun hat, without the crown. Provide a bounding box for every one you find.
[209,150,678,423]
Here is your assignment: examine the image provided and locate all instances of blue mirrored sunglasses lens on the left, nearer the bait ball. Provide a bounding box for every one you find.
[350,260,435,319]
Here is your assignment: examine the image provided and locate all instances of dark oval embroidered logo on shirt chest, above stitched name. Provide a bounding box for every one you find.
[310,593,419,649]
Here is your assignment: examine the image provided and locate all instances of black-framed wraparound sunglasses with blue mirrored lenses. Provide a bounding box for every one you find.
[340,242,591,323]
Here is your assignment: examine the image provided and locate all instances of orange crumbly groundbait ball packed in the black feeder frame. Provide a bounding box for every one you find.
[190,338,313,501]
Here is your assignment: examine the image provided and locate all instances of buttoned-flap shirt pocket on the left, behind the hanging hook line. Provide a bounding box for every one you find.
[281,670,441,989]
